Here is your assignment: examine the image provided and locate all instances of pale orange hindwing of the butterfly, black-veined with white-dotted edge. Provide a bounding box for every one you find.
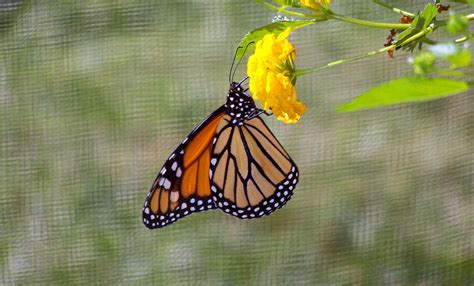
[210,115,298,219]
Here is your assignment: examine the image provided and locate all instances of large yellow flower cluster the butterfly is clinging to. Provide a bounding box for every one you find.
[247,28,306,123]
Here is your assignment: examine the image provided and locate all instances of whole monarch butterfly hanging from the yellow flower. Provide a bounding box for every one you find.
[142,47,298,229]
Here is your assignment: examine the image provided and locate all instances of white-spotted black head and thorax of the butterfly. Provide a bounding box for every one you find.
[225,82,258,124]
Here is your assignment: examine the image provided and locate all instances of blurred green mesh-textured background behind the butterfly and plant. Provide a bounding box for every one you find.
[0,0,474,285]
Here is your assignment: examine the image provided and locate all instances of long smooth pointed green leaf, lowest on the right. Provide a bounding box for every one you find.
[336,77,469,112]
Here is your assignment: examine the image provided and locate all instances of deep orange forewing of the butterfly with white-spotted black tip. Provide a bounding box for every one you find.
[142,107,225,229]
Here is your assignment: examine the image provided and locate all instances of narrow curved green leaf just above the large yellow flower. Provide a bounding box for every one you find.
[236,20,317,61]
